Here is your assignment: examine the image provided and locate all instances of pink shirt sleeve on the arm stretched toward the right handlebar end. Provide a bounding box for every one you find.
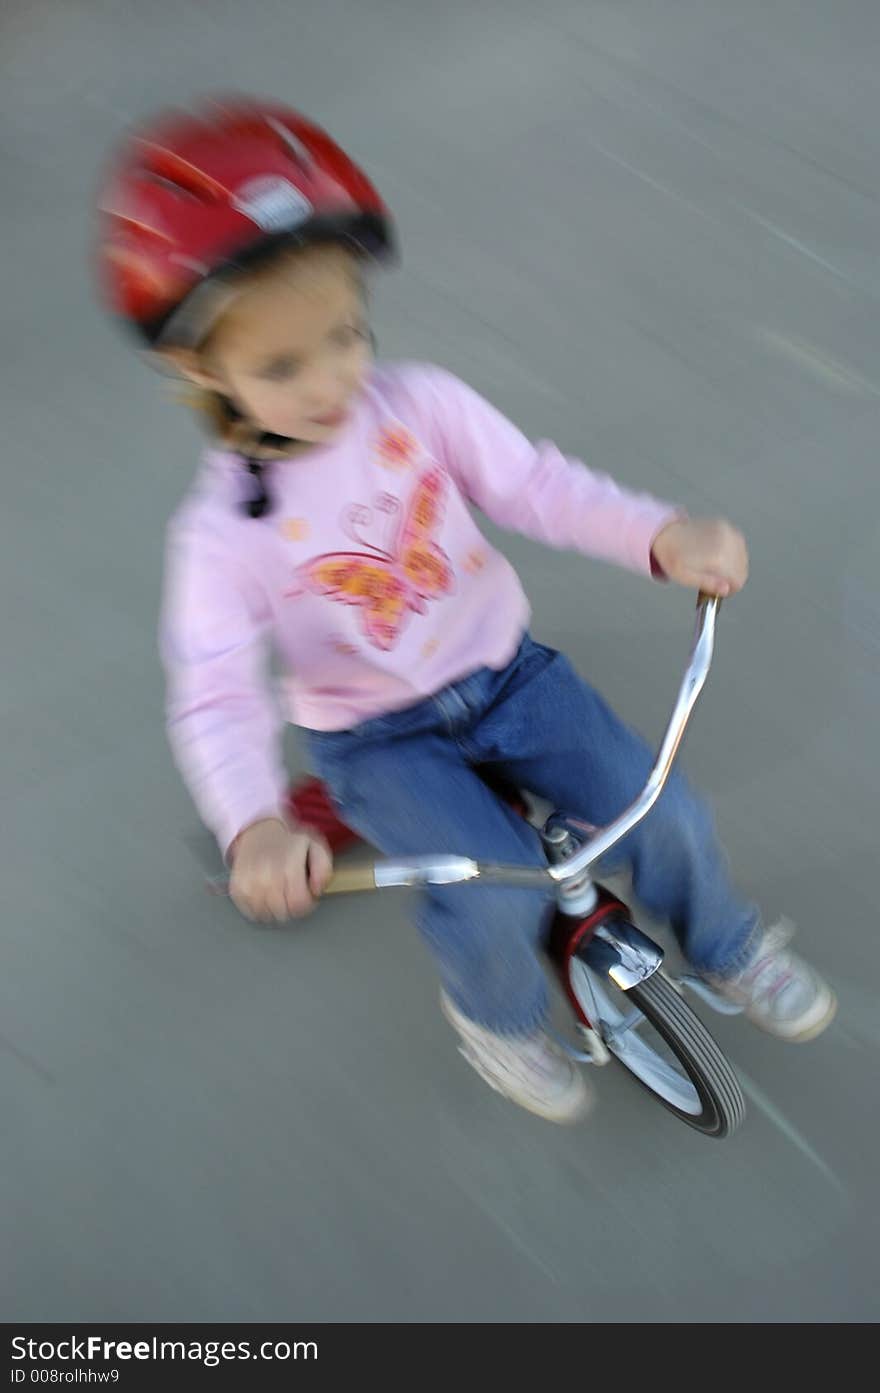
[423,368,684,575]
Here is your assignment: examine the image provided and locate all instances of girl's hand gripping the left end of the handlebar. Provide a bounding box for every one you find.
[230,818,333,924]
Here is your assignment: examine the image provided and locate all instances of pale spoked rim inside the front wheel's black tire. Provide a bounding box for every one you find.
[569,957,703,1117]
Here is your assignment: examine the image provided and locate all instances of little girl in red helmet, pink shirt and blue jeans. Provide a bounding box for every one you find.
[99,100,835,1121]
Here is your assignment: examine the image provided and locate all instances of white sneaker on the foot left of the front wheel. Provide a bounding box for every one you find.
[440,992,593,1123]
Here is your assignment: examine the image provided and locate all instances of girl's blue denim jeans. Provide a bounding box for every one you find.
[306,635,757,1035]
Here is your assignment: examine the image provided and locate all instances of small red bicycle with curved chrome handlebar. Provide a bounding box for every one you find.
[214,595,745,1139]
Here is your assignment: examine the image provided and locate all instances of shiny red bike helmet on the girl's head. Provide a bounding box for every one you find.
[97,98,394,345]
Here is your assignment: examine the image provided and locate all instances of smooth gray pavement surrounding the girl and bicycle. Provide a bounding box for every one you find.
[0,0,880,1322]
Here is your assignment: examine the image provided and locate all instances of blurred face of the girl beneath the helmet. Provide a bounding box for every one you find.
[192,247,372,444]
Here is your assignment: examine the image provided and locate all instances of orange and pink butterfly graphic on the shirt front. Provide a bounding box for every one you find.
[285,465,454,652]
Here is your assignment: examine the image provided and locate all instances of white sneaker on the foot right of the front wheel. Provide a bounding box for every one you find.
[706,919,837,1042]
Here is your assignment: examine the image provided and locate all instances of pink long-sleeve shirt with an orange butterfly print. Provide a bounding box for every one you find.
[160,364,678,853]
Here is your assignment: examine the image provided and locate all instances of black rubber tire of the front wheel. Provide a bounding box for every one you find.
[601,972,745,1141]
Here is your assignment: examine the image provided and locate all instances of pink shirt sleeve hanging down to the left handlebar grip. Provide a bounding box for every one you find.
[159,509,287,859]
